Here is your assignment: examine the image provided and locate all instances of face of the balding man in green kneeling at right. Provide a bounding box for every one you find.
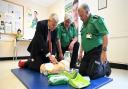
[78,8,88,22]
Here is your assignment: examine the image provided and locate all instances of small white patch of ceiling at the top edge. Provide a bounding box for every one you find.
[25,0,57,7]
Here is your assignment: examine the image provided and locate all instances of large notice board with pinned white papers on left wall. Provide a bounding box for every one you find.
[0,1,24,33]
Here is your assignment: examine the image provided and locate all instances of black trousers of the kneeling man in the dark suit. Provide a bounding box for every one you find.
[26,55,50,72]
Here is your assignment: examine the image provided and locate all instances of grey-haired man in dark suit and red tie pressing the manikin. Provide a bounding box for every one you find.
[18,13,58,71]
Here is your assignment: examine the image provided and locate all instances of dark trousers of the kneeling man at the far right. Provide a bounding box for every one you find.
[79,45,106,79]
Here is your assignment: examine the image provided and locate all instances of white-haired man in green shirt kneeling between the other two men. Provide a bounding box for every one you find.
[57,14,79,68]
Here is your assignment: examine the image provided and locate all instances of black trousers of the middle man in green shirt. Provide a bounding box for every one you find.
[62,42,79,68]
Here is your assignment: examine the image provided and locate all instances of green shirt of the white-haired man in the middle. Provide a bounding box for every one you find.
[57,23,77,47]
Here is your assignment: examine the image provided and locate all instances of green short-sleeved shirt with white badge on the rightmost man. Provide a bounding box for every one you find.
[81,15,108,52]
